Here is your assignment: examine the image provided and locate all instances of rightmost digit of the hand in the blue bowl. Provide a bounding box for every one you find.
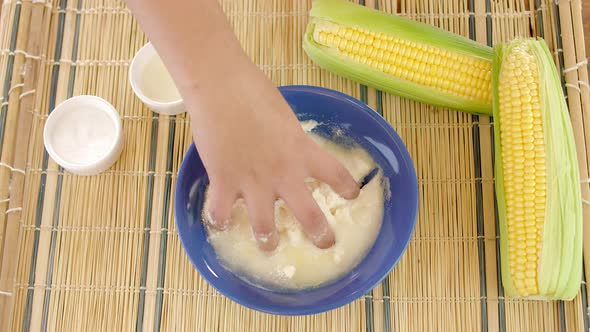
[310,150,360,199]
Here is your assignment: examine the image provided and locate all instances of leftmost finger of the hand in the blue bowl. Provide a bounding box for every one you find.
[205,183,238,230]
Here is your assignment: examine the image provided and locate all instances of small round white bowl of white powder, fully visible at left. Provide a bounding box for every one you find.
[43,95,123,175]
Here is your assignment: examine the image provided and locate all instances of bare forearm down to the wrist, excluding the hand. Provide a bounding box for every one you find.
[127,0,253,116]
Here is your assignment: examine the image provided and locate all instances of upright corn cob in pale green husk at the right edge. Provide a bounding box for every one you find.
[492,39,582,300]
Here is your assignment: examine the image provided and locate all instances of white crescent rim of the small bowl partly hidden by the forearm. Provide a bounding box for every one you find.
[129,42,185,115]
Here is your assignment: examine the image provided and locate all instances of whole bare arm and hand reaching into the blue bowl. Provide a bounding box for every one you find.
[127,0,359,250]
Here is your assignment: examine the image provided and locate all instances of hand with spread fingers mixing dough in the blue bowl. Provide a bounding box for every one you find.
[191,64,359,251]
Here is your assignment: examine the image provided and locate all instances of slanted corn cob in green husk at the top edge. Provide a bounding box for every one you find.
[303,0,493,115]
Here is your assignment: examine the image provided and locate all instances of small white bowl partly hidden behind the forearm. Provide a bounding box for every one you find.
[129,43,185,115]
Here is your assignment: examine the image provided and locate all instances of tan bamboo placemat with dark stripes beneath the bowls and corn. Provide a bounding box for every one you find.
[0,0,590,331]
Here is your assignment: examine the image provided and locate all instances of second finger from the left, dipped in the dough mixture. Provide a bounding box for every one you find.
[246,190,279,251]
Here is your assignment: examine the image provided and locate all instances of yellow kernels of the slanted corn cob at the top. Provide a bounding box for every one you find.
[314,22,491,104]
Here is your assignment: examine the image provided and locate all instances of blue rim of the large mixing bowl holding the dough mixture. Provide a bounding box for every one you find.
[174,85,419,316]
